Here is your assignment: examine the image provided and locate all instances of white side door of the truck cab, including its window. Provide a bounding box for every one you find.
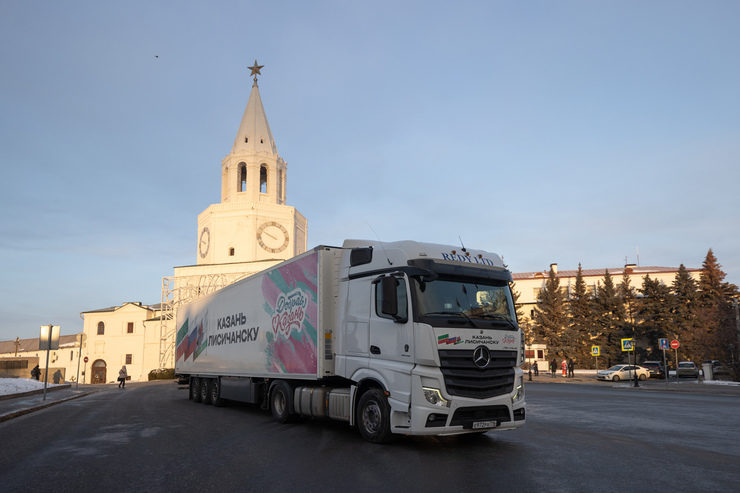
[369,273,414,402]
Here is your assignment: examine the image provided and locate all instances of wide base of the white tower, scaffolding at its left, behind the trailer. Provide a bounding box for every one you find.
[159,272,254,368]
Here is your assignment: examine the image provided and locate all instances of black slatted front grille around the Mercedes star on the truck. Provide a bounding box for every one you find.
[439,349,516,399]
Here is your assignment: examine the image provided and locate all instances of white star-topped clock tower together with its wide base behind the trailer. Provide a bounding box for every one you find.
[159,60,307,368]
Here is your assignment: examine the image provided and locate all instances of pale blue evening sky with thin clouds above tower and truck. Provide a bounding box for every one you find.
[0,0,740,340]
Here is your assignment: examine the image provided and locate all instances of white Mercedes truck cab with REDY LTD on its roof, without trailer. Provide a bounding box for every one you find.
[334,240,525,441]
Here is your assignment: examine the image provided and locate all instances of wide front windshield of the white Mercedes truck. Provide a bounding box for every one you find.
[411,277,517,330]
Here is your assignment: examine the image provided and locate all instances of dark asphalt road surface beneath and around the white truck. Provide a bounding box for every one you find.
[0,382,740,492]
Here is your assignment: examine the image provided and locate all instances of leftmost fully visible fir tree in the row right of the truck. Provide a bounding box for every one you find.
[534,268,567,356]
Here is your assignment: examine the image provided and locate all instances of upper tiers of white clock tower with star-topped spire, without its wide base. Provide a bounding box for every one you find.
[197,61,307,265]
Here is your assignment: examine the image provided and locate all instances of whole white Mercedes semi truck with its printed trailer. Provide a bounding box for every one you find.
[175,240,525,442]
